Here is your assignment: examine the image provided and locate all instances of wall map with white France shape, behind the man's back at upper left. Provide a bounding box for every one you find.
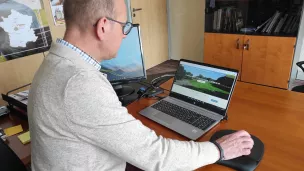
[0,0,52,62]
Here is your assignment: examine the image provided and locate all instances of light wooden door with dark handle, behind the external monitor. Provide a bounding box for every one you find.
[131,0,169,69]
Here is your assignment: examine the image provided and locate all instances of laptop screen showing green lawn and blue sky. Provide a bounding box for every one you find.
[170,60,238,115]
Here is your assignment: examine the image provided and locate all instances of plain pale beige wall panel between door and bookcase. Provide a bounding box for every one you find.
[167,0,206,62]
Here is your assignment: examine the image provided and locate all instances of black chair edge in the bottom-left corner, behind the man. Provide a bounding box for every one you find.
[0,139,27,171]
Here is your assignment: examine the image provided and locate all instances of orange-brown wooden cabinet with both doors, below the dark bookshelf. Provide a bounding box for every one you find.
[204,33,296,89]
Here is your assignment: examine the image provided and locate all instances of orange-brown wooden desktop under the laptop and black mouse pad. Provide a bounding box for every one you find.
[128,80,304,171]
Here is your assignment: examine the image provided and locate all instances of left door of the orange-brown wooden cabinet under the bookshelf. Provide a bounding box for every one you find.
[204,33,244,71]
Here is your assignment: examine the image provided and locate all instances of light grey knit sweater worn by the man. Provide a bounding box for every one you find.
[28,43,219,171]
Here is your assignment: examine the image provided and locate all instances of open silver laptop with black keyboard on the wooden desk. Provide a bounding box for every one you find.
[140,59,239,140]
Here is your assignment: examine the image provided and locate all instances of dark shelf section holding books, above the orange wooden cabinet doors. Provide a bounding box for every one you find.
[205,0,303,37]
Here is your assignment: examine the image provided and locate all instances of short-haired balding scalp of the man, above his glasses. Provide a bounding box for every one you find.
[63,0,115,30]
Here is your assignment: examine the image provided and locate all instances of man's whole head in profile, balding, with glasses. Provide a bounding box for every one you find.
[63,0,127,61]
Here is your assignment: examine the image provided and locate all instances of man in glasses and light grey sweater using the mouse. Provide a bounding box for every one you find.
[28,0,253,171]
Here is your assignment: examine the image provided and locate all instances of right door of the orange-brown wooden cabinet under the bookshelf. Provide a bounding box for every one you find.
[241,36,296,89]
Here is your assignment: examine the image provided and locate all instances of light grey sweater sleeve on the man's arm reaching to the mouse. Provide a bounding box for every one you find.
[64,72,219,170]
